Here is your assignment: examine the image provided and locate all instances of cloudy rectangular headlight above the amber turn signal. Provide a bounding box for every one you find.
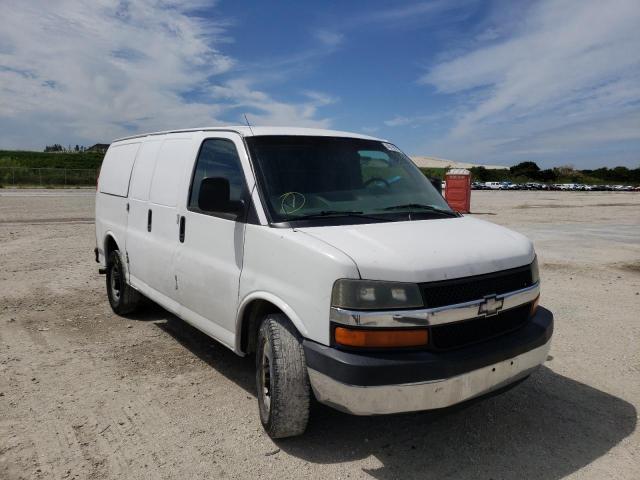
[331,278,423,310]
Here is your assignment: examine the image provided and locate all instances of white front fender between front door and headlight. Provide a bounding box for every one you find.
[236,224,359,350]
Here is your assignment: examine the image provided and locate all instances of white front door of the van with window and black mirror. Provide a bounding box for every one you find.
[175,132,253,348]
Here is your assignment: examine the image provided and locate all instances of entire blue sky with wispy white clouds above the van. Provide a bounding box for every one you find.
[0,0,640,168]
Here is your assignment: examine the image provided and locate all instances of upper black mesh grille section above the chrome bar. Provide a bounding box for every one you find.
[420,265,533,308]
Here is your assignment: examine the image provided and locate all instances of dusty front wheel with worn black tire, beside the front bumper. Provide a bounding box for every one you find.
[256,314,311,438]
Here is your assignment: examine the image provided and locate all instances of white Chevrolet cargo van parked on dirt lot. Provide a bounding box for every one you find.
[96,127,553,437]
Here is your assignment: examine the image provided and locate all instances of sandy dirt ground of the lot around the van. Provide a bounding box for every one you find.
[0,189,640,480]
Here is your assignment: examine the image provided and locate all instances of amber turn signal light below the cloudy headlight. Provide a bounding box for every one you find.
[334,327,429,348]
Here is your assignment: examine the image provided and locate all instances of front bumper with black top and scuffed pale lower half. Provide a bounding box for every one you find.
[304,308,553,415]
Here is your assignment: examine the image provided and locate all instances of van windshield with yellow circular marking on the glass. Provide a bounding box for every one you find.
[247,135,455,223]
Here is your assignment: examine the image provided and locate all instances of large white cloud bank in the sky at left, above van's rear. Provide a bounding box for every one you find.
[0,0,336,148]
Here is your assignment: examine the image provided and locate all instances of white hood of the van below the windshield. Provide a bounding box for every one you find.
[296,217,535,283]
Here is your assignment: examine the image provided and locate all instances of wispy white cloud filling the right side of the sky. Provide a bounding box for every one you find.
[420,0,640,167]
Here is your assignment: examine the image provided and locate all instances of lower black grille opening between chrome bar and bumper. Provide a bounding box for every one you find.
[430,303,531,350]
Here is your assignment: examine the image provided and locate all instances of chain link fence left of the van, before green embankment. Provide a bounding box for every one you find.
[0,167,98,187]
